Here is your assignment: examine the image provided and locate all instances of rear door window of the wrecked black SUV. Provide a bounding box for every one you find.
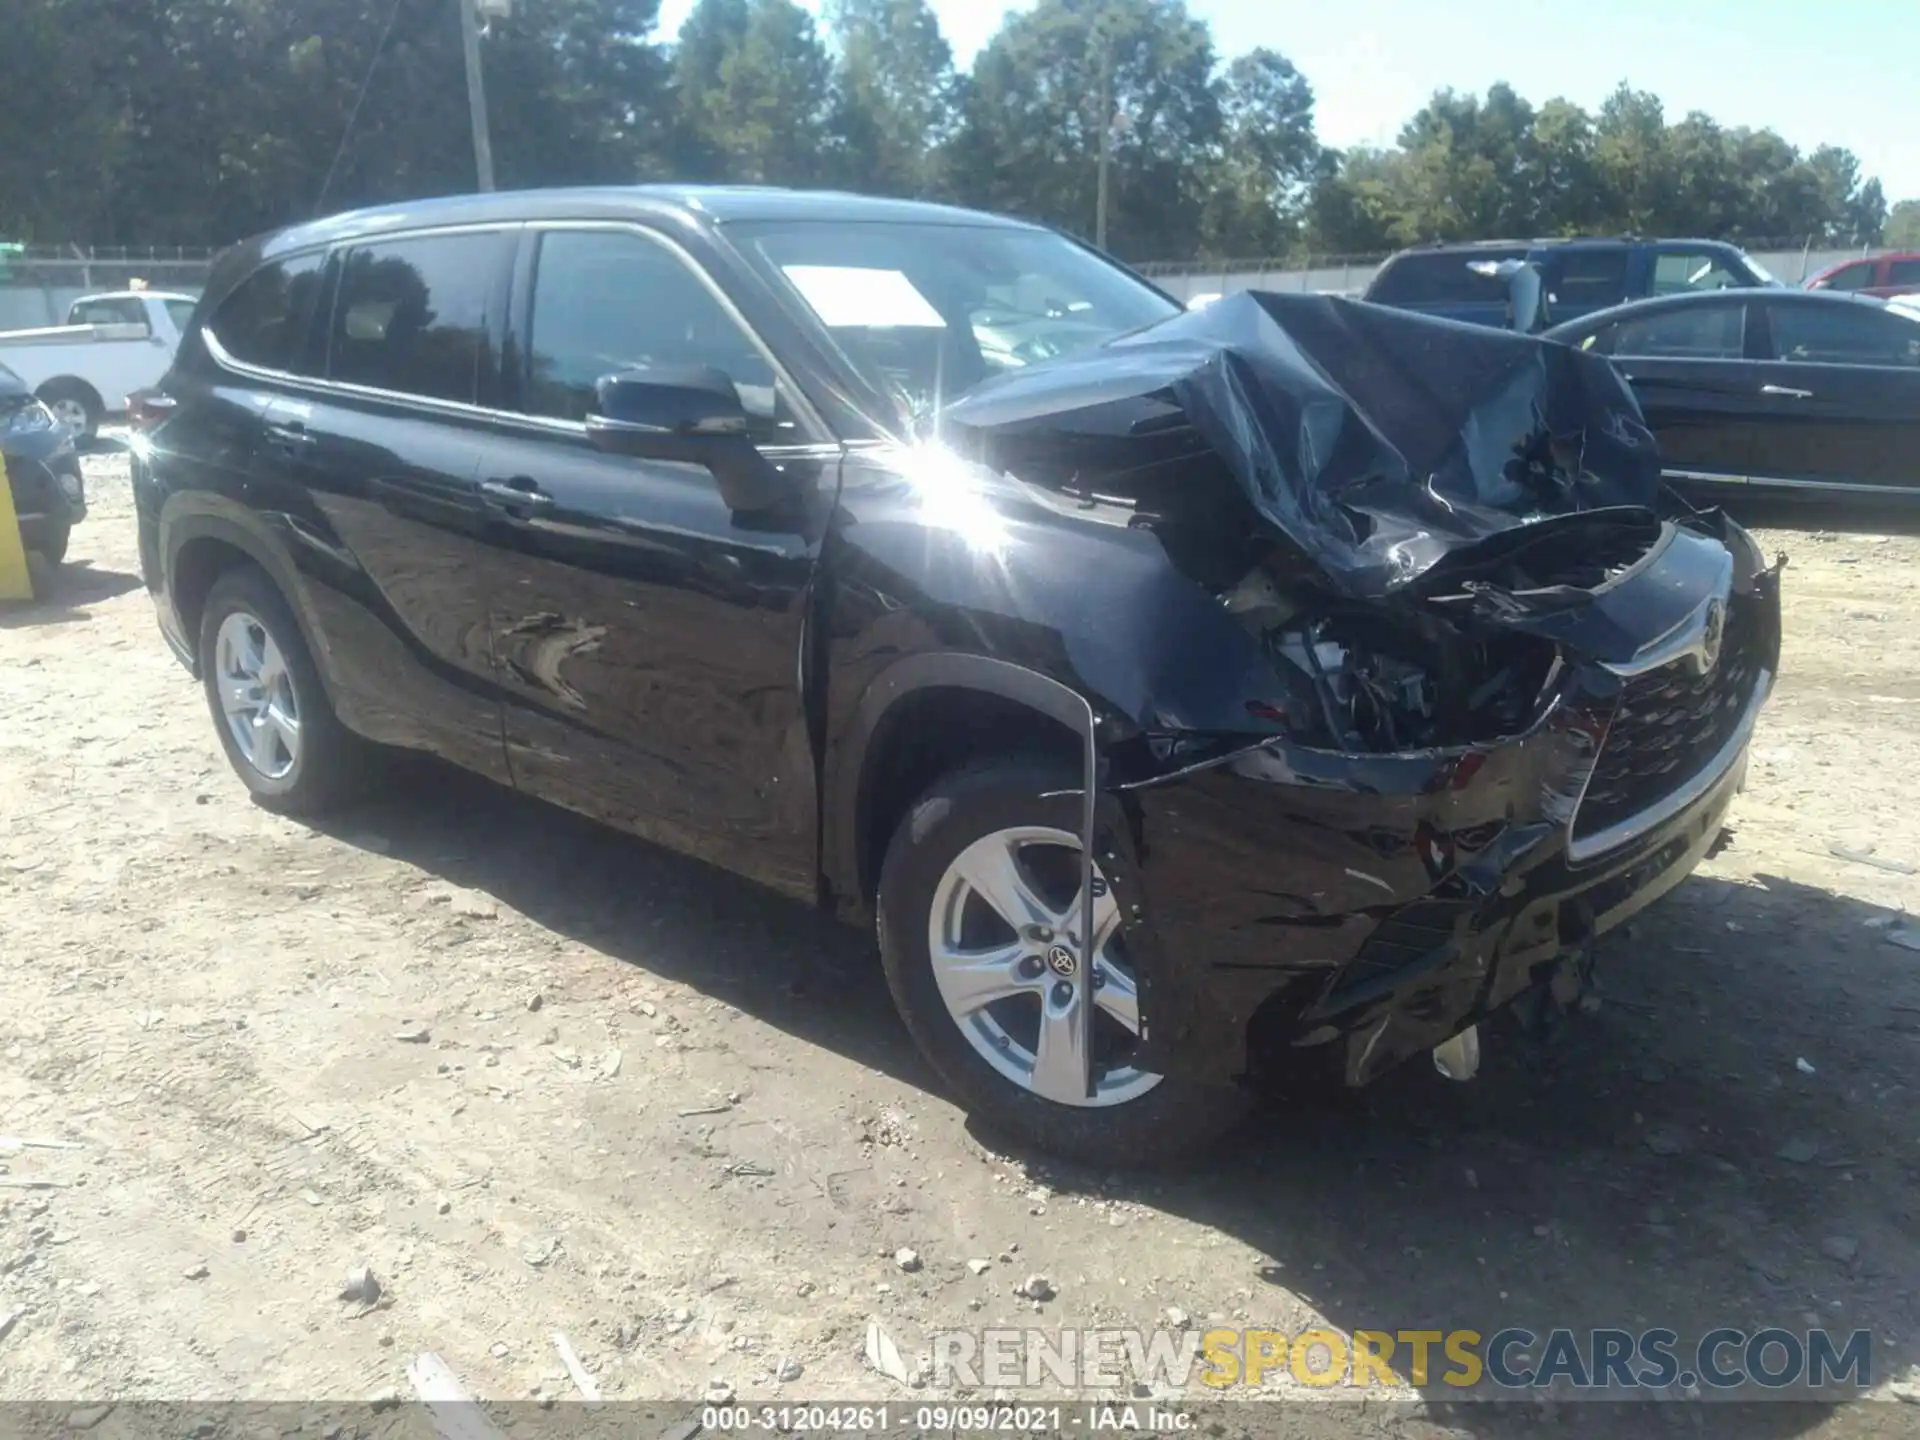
[326,232,503,403]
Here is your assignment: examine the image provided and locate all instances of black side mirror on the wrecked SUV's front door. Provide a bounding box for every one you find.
[588,365,793,513]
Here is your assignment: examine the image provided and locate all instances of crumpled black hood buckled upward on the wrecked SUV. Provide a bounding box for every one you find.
[941,292,1661,599]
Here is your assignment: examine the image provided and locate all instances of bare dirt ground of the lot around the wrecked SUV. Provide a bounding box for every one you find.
[0,457,1920,1440]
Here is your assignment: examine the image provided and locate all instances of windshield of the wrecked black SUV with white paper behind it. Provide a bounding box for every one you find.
[728,221,1181,422]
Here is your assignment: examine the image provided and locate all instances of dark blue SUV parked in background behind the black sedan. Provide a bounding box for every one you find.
[1363,238,1778,326]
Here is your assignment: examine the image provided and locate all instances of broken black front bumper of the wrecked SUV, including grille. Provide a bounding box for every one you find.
[1102,532,1780,1085]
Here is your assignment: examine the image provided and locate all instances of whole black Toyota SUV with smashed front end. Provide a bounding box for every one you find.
[136,188,1778,1162]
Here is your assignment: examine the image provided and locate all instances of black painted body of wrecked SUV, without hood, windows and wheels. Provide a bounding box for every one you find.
[136,190,1778,1081]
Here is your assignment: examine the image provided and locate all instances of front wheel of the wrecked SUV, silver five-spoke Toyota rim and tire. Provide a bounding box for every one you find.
[876,760,1246,1167]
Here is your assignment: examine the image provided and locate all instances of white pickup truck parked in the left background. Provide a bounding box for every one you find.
[0,290,194,442]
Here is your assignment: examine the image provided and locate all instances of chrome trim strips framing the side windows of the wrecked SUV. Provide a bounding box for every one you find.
[200,221,841,445]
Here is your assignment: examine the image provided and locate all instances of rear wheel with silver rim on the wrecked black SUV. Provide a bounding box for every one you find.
[200,564,371,814]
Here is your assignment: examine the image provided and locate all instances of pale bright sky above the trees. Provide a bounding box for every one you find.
[660,0,1920,202]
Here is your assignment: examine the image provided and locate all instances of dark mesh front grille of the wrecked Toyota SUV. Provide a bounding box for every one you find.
[1572,597,1768,841]
